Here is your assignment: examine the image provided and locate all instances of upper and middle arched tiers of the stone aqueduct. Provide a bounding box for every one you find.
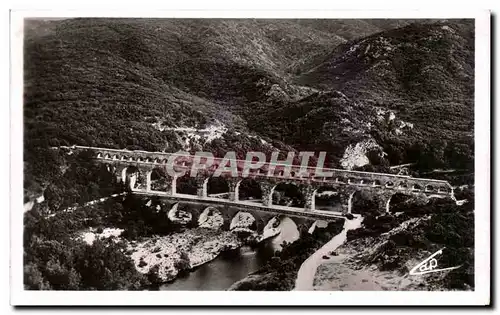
[71,146,453,218]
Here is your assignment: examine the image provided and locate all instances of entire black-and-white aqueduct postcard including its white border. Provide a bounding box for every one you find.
[11,8,490,304]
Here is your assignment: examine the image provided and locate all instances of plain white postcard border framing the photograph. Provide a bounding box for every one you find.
[10,9,491,305]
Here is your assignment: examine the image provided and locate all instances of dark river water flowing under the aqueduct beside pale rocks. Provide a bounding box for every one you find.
[160,217,299,291]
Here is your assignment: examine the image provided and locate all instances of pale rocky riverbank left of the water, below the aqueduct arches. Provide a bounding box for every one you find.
[72,206,292,285]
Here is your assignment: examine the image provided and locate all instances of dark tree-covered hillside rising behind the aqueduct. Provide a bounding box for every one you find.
[24,19,474,198]
